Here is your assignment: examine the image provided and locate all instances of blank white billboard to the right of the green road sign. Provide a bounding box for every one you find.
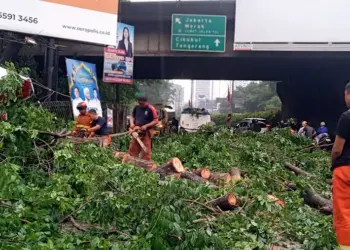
[234,0,350,51]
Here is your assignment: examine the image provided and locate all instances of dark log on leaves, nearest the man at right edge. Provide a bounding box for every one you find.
[301,188,333,214]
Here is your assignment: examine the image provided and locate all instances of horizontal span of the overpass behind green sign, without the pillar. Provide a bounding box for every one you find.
[50,1,350,80]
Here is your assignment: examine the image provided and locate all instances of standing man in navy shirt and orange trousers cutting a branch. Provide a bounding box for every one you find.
[129,94,158,160]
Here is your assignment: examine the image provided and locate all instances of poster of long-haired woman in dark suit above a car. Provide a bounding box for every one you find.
[103,23,134,84]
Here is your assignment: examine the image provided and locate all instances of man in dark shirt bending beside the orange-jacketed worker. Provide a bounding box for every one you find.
[88,109,111,148]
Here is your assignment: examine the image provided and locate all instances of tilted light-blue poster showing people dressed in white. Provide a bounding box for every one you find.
[66,58,102,118]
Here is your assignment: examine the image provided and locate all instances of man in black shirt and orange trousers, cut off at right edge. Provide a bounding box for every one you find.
[331,82,350,250]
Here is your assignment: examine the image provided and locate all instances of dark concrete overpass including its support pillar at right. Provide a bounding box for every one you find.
[34,1,350,125]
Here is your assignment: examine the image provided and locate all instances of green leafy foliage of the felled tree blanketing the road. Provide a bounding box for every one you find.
[0,65,335,250]
